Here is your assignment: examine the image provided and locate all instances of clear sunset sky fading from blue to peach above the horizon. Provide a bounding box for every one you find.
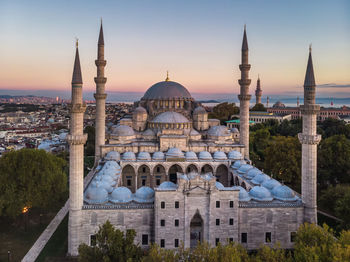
[0,0,350,97]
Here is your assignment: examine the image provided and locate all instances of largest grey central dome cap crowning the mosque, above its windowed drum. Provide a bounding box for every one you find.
[142,81,192,100]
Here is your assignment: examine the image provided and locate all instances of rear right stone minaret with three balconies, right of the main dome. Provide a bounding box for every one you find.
[238,26,251,159]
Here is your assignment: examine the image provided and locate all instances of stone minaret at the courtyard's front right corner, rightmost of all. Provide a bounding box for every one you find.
[298,46,321,223]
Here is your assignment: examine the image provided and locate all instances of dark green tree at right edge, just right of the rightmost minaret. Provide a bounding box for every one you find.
[317,135,350,188]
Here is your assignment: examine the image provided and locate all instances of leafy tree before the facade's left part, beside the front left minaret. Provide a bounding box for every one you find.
[78,220,142,262]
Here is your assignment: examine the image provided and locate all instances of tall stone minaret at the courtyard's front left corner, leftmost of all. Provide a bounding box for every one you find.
[67,41,87,256]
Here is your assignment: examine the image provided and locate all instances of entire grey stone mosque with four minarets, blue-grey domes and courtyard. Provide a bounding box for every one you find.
[67,24,320,256]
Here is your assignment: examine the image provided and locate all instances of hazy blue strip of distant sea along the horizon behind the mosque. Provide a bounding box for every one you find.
[0,89,350,107]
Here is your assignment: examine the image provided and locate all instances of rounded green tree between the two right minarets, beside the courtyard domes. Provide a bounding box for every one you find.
[264,136,301,192]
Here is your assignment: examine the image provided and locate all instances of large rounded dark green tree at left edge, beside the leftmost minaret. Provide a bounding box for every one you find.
[0,148,67,217]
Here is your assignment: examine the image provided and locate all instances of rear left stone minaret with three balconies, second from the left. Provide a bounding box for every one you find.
[94,20,107,162]
